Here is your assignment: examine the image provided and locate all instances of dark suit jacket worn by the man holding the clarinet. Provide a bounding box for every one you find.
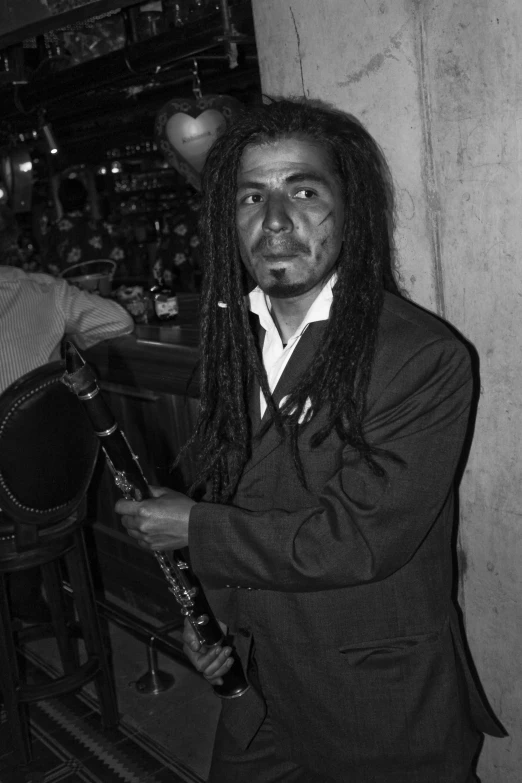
[189,294,502,783]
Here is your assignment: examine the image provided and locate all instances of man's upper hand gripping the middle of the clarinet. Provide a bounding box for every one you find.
[114,487,195,551]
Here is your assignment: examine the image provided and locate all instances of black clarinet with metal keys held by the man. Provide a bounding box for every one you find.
[63,341,250,699]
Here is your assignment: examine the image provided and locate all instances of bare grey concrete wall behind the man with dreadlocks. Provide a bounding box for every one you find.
[253,0,522,783]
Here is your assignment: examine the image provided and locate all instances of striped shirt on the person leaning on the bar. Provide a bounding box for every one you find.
[0,266,134,393]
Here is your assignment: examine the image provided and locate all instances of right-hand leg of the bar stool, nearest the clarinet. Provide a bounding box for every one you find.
[65,530,119,728]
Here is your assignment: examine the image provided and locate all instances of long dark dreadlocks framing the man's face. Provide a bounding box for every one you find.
[182,99,399,502]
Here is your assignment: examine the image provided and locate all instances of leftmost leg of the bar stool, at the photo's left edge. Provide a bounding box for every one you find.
[0,573,32,765]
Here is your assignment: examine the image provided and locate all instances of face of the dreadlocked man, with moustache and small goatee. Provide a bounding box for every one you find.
[236,138,344,299]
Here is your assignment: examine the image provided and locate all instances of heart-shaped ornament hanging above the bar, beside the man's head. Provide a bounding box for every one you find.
[155,95,242,190]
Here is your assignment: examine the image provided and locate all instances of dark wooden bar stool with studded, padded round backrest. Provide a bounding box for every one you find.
[0,362,118,765]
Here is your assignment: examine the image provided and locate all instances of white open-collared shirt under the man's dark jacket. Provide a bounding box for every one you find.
[248,273,337,416]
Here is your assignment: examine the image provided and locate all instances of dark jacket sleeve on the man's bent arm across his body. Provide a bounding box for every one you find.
[189,338,472,591]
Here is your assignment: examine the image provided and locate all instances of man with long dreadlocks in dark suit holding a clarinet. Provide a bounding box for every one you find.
[116,100,502,783]
